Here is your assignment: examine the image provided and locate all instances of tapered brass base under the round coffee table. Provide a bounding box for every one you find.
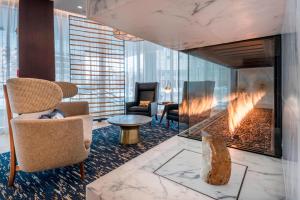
[120,126,140,144]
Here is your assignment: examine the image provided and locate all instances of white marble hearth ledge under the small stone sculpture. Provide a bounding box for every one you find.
[86,136,285,200]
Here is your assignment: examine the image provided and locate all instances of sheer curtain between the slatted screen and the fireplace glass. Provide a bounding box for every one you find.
[125,41,179,102]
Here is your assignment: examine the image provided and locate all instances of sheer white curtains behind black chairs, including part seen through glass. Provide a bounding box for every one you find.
[125,41,231,104]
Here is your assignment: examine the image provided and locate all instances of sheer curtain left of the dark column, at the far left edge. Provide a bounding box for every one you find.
[0,0,18,134]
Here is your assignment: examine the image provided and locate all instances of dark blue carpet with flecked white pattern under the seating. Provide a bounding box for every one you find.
[0,119,178,200]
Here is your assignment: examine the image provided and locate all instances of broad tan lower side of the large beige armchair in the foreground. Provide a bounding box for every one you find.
[11,117,89,172]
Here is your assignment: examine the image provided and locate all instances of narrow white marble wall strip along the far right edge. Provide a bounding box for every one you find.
[282,0,300,200]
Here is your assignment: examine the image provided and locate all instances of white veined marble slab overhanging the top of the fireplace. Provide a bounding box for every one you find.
[87,0,285,50]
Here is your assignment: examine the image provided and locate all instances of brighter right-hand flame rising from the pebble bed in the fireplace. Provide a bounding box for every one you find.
[227,89,266,134]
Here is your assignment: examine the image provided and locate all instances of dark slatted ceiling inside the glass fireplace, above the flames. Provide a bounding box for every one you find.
[189,37,276,69]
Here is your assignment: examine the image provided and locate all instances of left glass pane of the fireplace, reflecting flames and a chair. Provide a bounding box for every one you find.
[179,54,232,134]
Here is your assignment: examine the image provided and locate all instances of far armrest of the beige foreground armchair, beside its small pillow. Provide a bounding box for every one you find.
[56,101,89,117]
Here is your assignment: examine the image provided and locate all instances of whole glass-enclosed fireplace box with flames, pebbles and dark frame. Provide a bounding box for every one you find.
[179,36,281,157]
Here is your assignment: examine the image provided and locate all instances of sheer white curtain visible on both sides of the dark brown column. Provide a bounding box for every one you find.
[0,3,75,134]
